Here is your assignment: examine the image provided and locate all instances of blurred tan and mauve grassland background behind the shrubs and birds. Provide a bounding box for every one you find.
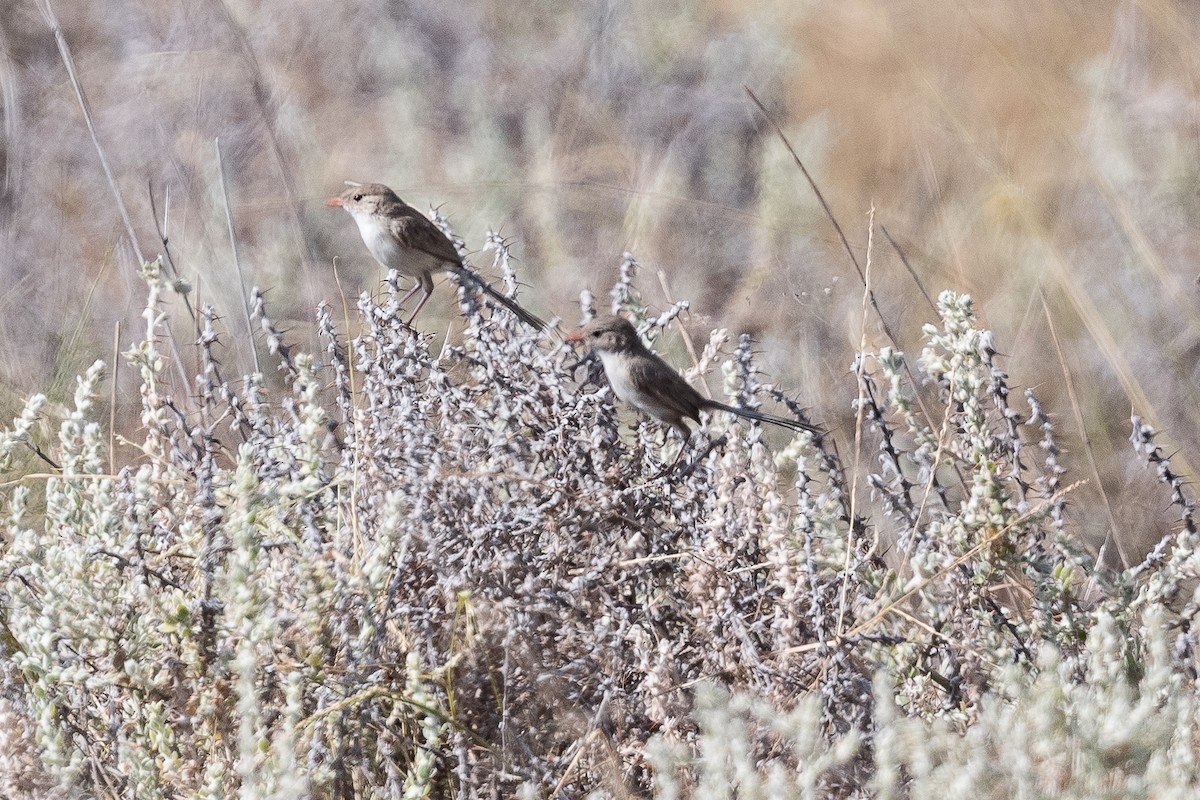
[0,0,1200,561]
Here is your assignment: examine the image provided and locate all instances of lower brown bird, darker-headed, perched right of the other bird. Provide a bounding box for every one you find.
[566,317,821,439]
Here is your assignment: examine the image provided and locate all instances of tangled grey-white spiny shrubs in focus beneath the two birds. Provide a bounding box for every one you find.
[0,237,1200,800]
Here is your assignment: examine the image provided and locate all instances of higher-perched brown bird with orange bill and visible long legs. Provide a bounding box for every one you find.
[325,181,546,330]
